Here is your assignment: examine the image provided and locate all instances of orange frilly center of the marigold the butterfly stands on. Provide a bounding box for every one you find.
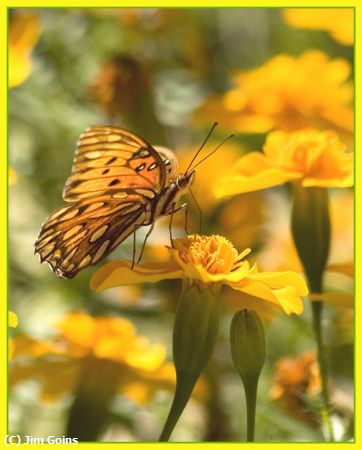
[174,235,239,274]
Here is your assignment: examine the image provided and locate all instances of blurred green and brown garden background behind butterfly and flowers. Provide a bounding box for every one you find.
[8,8,353,442]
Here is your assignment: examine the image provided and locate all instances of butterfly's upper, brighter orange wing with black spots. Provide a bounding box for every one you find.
[63,127,167,202]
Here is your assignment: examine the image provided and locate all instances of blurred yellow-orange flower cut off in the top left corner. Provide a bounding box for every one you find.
[8,11,40,87]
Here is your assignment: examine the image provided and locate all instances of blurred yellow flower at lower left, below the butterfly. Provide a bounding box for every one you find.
[10,312,179,403]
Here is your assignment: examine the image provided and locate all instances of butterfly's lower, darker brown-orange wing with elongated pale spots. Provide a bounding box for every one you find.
[35,195,146,278]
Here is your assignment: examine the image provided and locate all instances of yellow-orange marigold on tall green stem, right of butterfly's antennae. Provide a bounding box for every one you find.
[215,130,353,197]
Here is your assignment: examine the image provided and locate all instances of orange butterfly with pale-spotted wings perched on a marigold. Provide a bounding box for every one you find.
[35,126,198,278]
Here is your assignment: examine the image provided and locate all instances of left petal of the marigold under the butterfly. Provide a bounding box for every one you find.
[90,260,183,291]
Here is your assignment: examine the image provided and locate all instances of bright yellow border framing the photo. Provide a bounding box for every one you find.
[0,0,362,450]
